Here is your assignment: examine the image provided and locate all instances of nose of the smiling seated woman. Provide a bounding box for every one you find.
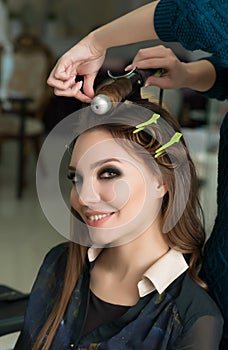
[77,180,100,206]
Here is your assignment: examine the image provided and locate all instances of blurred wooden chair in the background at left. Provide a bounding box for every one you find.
[0,34,54,198]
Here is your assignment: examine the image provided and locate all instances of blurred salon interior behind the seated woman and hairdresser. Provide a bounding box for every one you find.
[0,0,228,350]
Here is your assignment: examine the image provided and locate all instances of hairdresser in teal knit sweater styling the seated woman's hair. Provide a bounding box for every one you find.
[48,0,228,349]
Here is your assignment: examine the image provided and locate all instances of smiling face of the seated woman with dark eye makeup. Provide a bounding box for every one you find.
[69,129,165,247]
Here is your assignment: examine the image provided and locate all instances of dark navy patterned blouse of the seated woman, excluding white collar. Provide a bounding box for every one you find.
[15,243,223,350]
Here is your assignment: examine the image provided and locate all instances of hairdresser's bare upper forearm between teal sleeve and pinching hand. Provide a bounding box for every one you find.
[89,1,159,50]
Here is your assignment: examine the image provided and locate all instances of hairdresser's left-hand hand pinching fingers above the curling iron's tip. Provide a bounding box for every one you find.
[47,35,106,103]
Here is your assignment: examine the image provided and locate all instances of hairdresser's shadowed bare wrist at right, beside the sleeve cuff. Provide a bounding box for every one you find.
[183,59,216,92]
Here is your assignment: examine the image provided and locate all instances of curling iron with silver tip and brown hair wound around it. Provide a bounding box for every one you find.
[91,68,163,115]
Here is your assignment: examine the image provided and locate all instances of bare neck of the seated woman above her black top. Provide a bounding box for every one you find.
[90,221,169,306]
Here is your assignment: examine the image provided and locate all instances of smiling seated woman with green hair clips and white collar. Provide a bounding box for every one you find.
[15,101,223,350]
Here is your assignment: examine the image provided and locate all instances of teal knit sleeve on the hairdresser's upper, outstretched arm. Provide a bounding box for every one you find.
[154,0,228,66]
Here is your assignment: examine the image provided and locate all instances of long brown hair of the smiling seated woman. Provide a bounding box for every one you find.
[33,100,206,350]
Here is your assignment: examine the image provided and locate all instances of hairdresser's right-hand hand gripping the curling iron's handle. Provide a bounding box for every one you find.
[126,45,188,89]
